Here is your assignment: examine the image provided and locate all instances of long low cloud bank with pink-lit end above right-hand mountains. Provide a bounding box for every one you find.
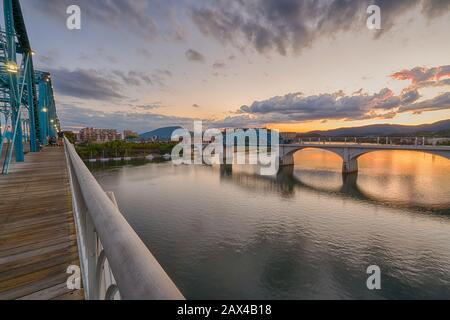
[212,66,450,127]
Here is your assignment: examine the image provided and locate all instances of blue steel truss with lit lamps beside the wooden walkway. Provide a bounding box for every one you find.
[0,0,60,174]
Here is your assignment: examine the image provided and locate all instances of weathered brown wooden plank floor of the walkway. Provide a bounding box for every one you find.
[0,147,84,299]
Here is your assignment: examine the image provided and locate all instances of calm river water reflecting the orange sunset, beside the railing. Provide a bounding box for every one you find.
[92,150,450,299]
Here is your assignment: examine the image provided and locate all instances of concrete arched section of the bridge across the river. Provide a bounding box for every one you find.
[280,142,450,173]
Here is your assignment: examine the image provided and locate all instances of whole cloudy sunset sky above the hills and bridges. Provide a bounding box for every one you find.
[11,0,450,132]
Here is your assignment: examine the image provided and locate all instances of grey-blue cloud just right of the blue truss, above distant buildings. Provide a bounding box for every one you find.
[48,68,125,100]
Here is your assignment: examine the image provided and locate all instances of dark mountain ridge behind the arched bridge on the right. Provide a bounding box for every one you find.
[302,119,450,137]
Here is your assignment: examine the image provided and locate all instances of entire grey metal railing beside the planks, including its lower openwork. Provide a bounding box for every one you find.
[65,139,184,300]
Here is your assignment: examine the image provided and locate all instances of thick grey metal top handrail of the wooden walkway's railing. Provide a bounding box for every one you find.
[65,138,184,300]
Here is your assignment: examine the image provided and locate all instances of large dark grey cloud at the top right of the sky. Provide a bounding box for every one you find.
[191,0,448,55]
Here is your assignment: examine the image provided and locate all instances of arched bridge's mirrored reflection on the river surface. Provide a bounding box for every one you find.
[220,165,450,215]
